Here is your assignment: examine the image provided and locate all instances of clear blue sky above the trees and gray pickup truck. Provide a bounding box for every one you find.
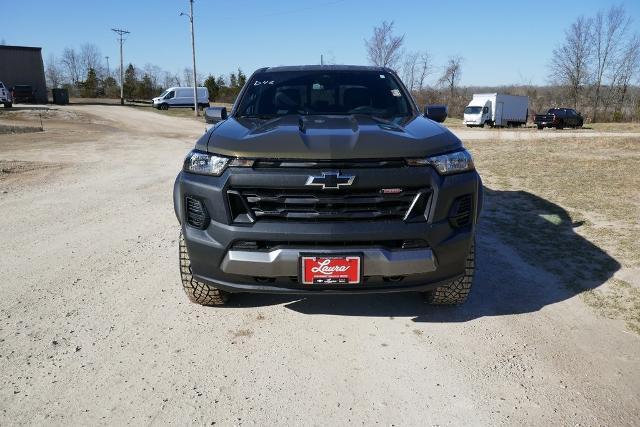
[5,0,640,85]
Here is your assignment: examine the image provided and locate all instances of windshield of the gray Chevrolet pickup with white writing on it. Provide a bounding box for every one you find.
[237,70,412,117]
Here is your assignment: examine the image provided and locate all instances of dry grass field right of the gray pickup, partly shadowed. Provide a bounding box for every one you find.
[467,137,640,333]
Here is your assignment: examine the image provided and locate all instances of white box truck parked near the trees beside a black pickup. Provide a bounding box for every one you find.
[464,93,529,127]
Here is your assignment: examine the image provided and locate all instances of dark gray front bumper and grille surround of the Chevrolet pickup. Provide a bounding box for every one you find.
[174,167,482,293]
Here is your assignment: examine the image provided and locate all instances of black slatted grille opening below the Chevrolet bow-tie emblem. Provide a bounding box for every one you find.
[230,189,424,221]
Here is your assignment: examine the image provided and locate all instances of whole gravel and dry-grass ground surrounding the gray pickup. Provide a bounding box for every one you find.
[0,106,640,425]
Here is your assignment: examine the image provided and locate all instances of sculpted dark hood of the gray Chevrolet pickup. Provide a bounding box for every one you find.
[196,115,462,160]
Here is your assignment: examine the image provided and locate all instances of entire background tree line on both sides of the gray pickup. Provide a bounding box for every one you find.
[46,6,640,122]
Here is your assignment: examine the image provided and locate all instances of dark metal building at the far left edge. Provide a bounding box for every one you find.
[0,45,48,104]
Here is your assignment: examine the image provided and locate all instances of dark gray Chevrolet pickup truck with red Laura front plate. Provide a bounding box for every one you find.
[173,66,482,305]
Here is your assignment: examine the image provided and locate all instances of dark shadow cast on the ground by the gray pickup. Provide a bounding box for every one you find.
[231,188,620,322]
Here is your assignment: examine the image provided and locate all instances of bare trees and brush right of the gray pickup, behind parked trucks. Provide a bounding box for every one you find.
[365,6,640,122]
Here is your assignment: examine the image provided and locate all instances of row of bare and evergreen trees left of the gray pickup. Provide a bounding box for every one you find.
[45,43,247,103]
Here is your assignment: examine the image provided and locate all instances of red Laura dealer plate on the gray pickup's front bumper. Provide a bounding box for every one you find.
[300,255,362,285]
